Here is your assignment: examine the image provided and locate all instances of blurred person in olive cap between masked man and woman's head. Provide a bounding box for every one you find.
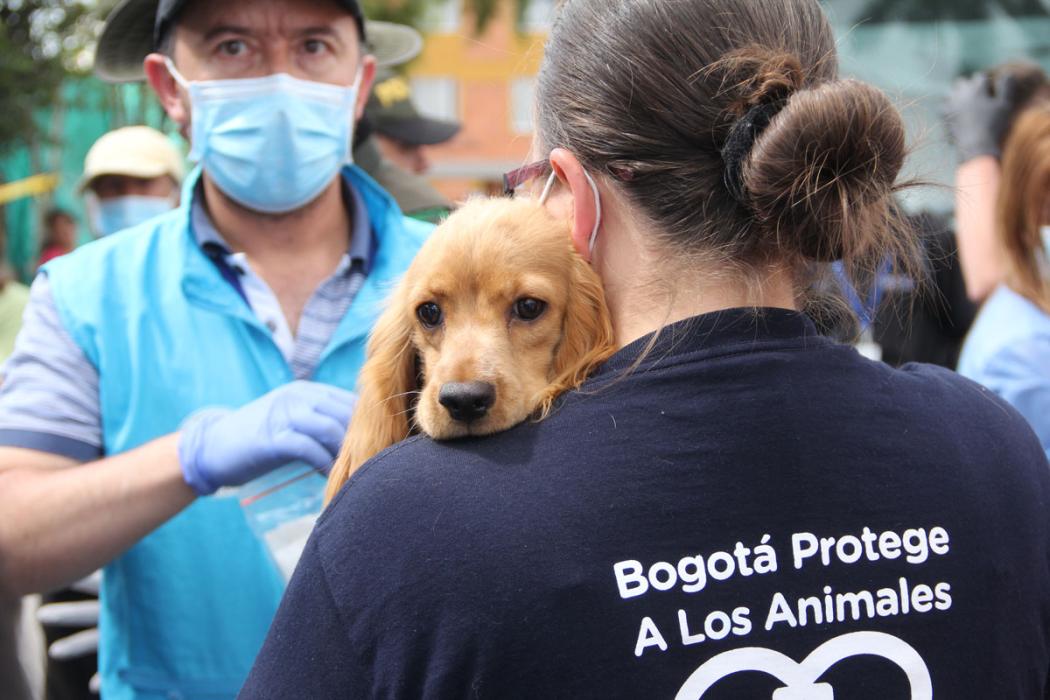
[354,70,460,221]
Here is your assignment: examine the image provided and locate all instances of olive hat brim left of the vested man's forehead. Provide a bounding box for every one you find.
[95,0,160,83]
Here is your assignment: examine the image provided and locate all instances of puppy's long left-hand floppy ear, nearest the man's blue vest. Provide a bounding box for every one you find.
[324,299,417,505]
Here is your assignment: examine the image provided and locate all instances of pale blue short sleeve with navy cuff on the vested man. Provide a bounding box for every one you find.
[0,274,102,462]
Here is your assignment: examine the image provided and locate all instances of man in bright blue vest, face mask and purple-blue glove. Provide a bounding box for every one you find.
[0,0,432,699]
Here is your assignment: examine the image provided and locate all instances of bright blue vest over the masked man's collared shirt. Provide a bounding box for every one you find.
[47,167,433,700]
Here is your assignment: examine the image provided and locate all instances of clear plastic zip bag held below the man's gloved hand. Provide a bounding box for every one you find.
[231,463,327,584]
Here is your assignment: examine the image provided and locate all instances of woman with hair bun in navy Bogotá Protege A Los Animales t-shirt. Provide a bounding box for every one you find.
[242,0,1050,700]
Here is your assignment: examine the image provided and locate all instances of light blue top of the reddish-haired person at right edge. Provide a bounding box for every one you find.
[981,338,1050,458]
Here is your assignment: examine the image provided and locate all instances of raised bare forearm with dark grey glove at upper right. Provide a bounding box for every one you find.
[945,62,1050,303]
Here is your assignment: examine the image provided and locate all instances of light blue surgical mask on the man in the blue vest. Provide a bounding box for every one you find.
[167,59,361,213]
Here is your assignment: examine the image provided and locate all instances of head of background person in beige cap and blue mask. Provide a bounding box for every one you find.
[80,126,184,237]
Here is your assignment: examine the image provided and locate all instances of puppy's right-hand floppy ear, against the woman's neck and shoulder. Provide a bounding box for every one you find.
[540,253,616,417]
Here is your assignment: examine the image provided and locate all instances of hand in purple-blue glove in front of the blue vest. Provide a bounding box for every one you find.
[179,381,357,495]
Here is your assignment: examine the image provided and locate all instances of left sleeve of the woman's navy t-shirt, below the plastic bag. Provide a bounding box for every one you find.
[237,532,369,700]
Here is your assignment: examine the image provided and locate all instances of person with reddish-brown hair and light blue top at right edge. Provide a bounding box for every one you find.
[959,105,1050,457]
